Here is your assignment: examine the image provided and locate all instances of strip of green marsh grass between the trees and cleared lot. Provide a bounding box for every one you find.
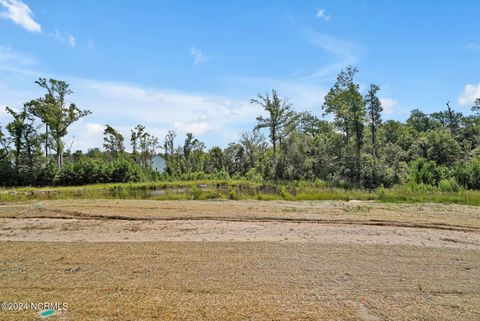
[0,180,480,205]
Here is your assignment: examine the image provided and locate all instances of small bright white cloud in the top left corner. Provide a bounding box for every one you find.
[0,0,42,32]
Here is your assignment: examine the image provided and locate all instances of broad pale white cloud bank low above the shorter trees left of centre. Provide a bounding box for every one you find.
[57,78,261,150]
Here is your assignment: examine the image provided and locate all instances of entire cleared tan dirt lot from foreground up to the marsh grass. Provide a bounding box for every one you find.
[0,200,480,321]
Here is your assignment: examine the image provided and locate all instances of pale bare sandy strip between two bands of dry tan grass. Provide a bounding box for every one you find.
[0,218,480,250]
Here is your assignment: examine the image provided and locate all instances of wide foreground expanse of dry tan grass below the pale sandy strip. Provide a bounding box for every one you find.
[0,242,480,321]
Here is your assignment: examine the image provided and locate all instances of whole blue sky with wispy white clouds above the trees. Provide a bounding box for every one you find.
[0,0,480,149]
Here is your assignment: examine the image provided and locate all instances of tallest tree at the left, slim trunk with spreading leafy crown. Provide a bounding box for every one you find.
[28,78,91,169]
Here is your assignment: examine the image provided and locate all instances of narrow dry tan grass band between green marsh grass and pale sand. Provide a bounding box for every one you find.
[0,200,480,230]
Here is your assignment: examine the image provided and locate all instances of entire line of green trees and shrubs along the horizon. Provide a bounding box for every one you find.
[0,66,480,191]
